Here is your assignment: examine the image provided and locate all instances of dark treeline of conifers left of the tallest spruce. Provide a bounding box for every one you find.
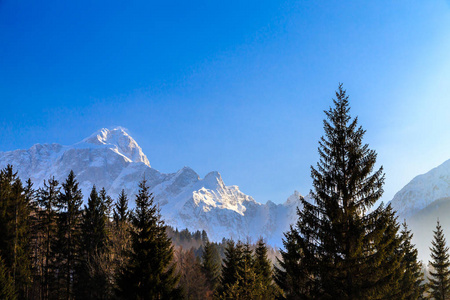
[0,166,278,299]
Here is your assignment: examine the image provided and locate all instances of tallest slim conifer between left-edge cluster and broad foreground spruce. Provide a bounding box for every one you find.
[53,171,83,299]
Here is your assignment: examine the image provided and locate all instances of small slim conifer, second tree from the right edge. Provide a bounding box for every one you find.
[400,222,425,300]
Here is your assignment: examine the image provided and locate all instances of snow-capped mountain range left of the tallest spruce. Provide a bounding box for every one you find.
[0,127,300,247]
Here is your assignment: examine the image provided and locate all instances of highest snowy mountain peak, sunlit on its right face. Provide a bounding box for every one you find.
[81,127,150,167]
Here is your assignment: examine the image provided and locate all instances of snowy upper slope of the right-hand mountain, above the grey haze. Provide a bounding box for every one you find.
[391,159,450,218]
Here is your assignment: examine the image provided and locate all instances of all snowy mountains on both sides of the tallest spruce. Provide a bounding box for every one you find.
[0,127,450,261]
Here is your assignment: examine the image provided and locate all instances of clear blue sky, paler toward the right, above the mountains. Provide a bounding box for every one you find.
[0,0,450,202]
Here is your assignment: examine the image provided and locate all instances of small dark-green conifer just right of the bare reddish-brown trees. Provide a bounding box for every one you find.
[201,240,220,292]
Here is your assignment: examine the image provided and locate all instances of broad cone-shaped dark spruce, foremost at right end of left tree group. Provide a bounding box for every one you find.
[118,179,182,299]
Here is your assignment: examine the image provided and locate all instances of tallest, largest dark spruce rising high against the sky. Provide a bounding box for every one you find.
[276,85,400,299]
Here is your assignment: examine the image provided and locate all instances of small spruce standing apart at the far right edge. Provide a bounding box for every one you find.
[428,220,450,300]
